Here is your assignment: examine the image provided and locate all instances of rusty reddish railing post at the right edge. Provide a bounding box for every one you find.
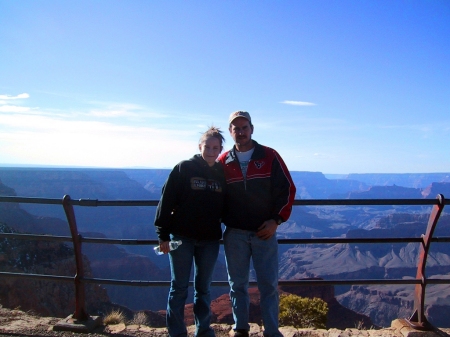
[406,194,445,330]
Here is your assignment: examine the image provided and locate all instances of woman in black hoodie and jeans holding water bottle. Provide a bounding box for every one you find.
[155,126,226,337]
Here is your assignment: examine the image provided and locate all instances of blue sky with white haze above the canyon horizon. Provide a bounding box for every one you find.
[0,0,450,174]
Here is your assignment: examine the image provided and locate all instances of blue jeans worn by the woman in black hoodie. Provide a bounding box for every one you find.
[166,236,220,337]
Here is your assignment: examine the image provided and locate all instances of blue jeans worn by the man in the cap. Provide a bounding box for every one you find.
[223,227,283,337]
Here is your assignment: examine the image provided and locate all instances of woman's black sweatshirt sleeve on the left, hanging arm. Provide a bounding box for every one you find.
[155,164,183,241]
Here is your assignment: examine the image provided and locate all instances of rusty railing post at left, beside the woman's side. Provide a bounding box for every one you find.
[62,195,89,321]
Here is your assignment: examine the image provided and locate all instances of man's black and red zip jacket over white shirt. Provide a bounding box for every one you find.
[218,140,296,231]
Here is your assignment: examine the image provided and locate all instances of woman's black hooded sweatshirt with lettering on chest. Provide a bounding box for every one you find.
[155,154,226,241]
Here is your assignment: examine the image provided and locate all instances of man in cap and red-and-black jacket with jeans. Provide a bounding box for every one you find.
[218,111,295,337]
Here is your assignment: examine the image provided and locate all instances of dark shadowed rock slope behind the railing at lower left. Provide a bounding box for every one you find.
[0,224,109,317]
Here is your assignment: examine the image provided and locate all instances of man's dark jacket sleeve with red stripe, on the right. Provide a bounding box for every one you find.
[271,150,296,222]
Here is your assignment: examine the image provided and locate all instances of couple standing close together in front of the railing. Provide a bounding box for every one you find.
[155,111,295,337]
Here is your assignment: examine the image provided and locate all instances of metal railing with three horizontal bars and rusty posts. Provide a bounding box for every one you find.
[0,194,450,330]
